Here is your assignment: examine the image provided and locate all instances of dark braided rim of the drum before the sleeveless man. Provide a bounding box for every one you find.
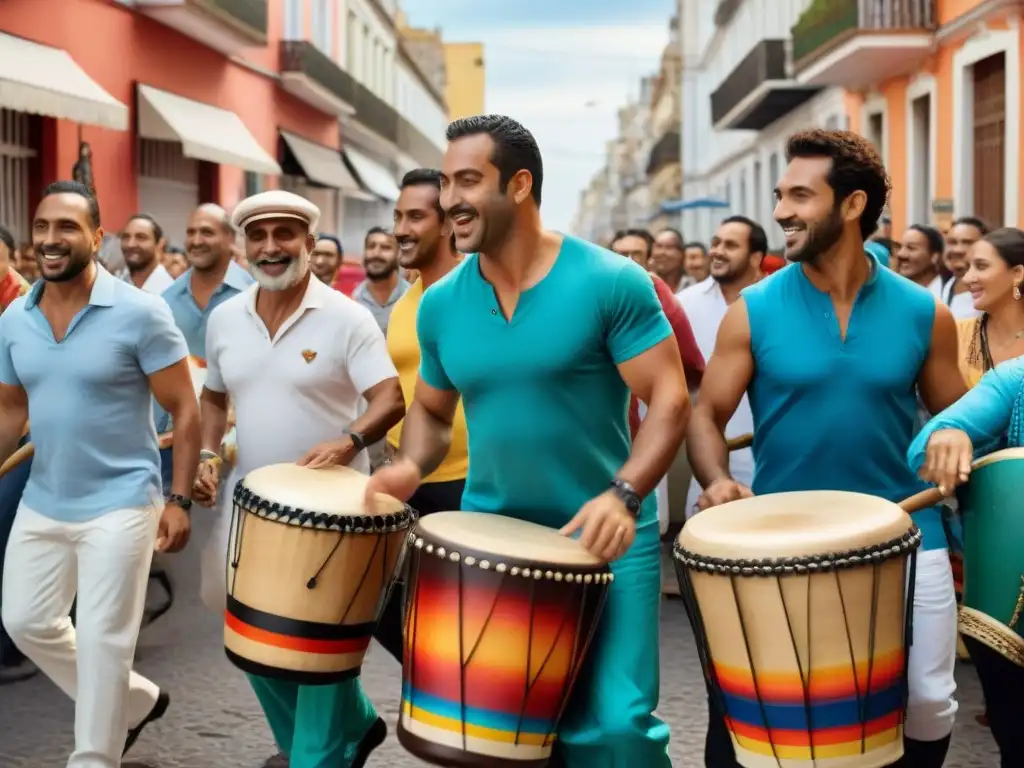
[672,522,922,577]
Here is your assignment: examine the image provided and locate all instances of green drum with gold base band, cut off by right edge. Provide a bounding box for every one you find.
[959,447,1024,667]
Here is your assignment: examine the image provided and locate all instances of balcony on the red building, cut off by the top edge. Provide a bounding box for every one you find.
[134,0,267,56]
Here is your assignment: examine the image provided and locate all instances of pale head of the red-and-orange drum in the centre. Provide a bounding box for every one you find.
[416,512,604,568]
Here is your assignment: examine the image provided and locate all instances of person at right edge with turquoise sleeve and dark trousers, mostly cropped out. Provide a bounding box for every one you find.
[907,357,1024,768]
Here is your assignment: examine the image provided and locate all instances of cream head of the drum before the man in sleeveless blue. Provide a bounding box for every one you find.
[679,490,912,560]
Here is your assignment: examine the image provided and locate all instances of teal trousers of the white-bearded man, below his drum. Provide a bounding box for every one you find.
[247,675,377,768]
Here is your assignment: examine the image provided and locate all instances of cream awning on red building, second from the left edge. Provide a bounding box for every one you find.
[138,84,281,176]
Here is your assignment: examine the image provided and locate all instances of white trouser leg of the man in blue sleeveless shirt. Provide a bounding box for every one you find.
[905,549,956,741]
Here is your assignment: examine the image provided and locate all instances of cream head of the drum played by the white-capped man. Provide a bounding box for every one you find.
[242,464,406,517]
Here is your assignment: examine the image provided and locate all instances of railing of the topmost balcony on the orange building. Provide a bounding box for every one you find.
[793,0,935,68]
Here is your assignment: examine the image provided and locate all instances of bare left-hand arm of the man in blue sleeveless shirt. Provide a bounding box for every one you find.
[686,298,754,510]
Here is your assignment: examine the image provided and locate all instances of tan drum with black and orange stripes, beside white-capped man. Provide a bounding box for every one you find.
[224,464,412,685]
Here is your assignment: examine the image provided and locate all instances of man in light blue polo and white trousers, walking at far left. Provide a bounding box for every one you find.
[0,181,200,768]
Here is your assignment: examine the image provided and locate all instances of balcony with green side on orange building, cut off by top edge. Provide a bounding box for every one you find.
[793,0,936,90]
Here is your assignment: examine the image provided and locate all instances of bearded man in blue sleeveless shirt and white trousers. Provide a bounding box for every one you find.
[688,130,965,768]
